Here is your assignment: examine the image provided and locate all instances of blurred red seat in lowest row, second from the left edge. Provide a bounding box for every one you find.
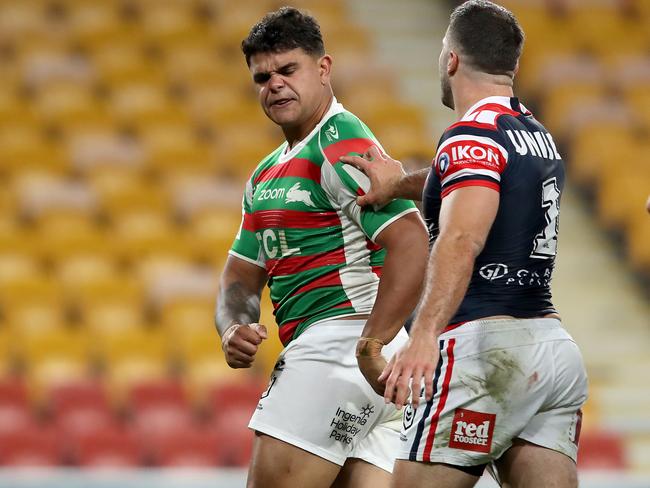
[75,429,141,468]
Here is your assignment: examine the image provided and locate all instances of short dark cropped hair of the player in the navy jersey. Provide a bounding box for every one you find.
[449,0,524,75]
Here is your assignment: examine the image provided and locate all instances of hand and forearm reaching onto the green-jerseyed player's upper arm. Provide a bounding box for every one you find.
[341,146,429,207]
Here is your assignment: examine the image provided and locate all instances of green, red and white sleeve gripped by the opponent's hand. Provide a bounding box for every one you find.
[319,115,418,242]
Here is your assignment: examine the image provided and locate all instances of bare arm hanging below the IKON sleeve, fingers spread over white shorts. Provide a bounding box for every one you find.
[380,186,499,408]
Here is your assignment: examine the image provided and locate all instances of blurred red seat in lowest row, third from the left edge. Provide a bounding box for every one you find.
[152,426,222,467]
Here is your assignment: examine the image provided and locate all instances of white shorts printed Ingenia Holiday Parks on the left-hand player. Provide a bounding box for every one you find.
[248,320,408,472]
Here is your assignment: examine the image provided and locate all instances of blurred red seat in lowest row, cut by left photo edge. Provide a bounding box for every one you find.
[0,425,60,466]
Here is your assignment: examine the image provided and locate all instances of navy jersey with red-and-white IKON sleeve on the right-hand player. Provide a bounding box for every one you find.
[423,97,564,325]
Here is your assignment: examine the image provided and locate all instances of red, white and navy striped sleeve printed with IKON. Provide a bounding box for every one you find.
[434,129,508,198]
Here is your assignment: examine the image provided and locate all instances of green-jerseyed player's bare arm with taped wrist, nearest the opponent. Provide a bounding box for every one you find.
[357,213,429,395]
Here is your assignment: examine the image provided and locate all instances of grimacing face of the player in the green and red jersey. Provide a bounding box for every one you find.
[250,48,329,128]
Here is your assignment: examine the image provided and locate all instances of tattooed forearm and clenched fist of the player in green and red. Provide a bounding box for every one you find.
[216,256,267,368]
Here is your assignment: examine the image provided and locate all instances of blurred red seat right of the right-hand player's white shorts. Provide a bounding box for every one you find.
[578,431,627,470]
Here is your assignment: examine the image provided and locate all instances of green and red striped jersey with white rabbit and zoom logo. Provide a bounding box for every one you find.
[230,100,417,345]
